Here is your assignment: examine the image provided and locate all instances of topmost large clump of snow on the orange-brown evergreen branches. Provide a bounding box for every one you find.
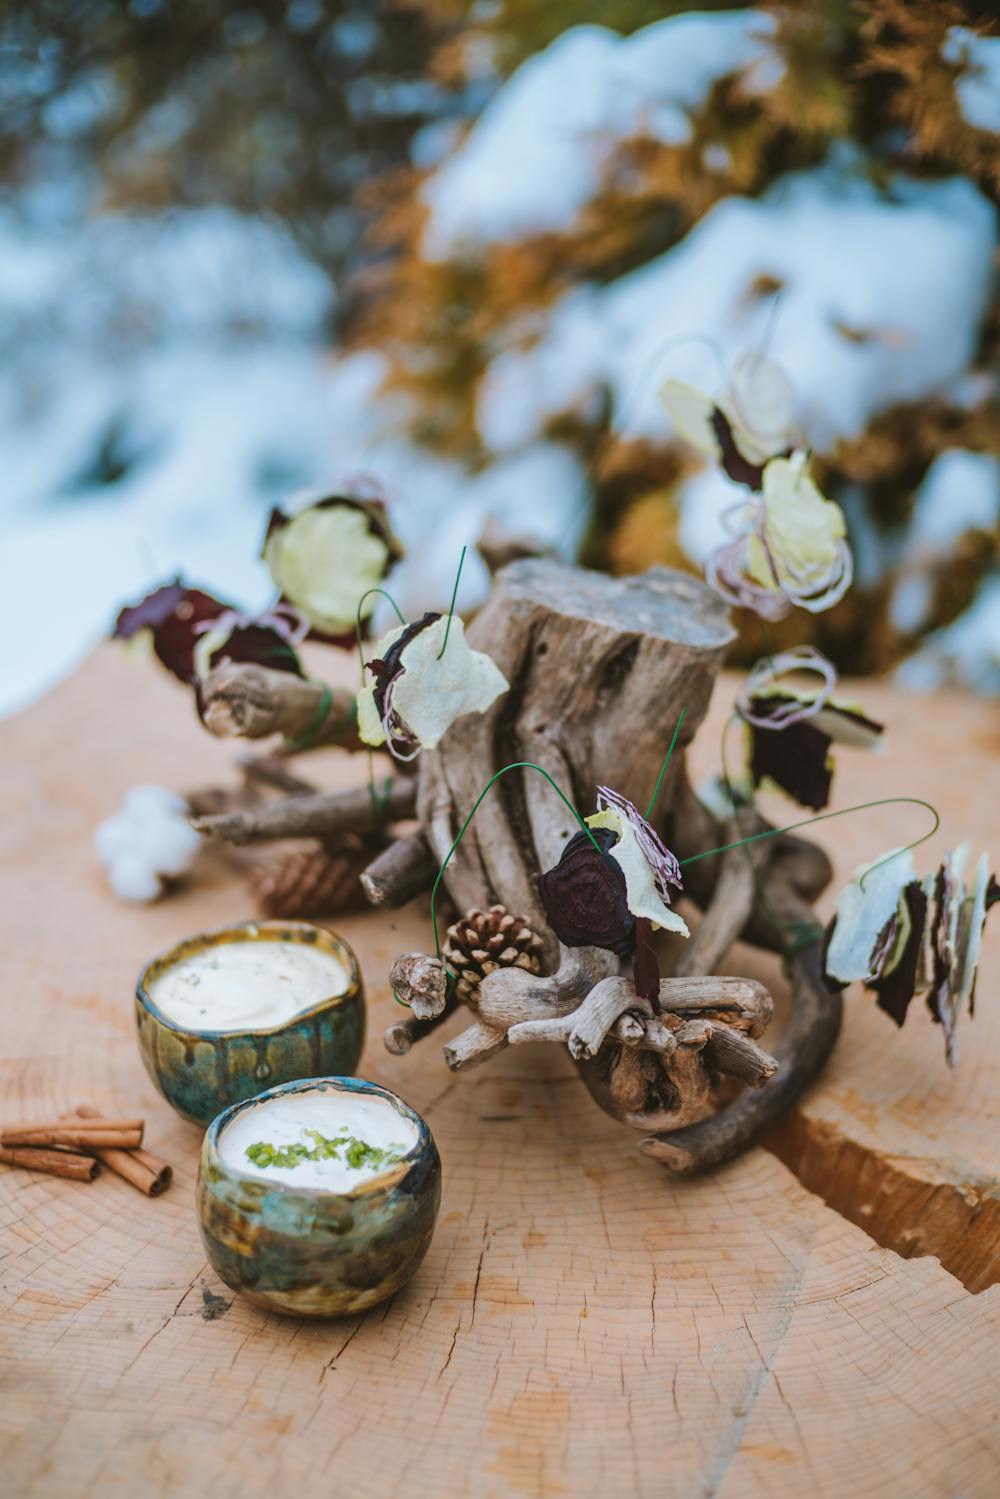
[424,10,781,259]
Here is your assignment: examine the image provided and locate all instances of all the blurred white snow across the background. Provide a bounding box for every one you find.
[0,6,1000,712]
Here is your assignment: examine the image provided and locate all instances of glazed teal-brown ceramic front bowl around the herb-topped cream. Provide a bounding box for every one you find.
[196,1078,441,1318]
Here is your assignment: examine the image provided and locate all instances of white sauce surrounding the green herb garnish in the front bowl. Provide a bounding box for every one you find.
[219,1087,418,1192]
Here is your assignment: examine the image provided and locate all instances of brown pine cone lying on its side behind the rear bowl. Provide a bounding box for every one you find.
[250,833,382,920]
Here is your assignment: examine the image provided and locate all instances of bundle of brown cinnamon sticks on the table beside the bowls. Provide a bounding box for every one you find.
[0,1103,174,1198]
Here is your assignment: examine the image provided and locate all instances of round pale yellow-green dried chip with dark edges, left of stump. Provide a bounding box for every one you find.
[261,495,402,645]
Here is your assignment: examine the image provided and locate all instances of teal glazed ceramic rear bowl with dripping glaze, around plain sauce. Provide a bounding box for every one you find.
[135,922,364,1124]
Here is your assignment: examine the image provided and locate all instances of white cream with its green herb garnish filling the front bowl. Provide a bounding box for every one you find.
[217,1088,420,1192]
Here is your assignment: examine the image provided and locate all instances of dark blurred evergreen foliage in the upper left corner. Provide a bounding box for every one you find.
[0,0,462,301]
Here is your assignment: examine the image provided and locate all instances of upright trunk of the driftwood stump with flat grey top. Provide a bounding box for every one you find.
[417,559,733,968]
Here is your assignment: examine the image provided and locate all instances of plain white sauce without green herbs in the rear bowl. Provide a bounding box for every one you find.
[148,937,349,1031]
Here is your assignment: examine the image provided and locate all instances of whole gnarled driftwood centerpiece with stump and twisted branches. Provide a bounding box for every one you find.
[193,558,841,1174]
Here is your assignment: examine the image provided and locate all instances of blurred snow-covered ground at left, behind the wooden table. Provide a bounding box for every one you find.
[0,210,586,712]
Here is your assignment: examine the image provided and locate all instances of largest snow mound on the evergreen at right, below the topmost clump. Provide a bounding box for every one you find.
[478,162,997,451]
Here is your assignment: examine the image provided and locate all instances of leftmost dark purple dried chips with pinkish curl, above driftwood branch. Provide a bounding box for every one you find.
[112,579,303,685]
